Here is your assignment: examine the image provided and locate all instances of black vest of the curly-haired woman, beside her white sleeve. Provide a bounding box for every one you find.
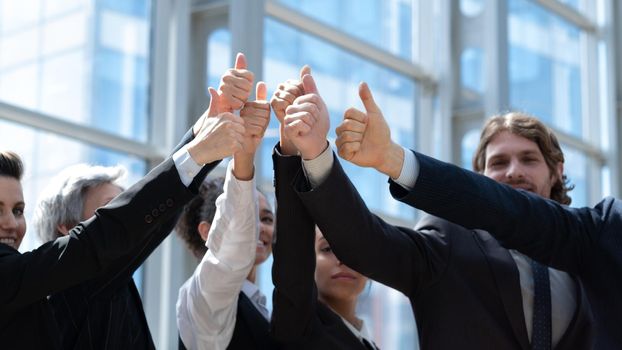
[179,292,280,350]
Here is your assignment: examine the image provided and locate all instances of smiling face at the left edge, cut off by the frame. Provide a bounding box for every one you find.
[0,175,26,249]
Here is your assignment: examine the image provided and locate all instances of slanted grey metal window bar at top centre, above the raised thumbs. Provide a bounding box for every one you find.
[265,0,436,88]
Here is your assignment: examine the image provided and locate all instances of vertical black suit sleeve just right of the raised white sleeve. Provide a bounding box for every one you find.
[271,146,318,345]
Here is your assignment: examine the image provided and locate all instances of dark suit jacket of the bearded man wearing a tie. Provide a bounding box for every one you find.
[295,152,591,350]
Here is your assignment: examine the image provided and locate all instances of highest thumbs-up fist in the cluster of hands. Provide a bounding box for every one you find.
[218,53,254,112]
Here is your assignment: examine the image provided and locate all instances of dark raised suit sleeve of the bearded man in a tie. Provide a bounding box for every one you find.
[294,155,450,295]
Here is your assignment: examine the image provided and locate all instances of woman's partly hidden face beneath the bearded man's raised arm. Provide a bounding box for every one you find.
[315,229,367,304]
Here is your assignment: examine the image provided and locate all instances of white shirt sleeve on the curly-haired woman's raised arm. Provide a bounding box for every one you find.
[177,161,259,350]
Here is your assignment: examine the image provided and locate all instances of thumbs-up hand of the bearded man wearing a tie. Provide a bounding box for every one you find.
[282,74,330,159]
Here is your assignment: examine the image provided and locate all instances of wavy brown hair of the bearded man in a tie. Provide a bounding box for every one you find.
[473,112,574,205]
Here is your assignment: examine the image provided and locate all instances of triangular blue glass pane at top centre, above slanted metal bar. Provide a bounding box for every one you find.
[278,0,413,59]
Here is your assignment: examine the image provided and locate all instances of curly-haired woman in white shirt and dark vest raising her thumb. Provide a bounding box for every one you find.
[177,59,277,349]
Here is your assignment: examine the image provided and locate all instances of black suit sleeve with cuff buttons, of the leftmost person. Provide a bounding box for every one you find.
[0,152,214,313]
